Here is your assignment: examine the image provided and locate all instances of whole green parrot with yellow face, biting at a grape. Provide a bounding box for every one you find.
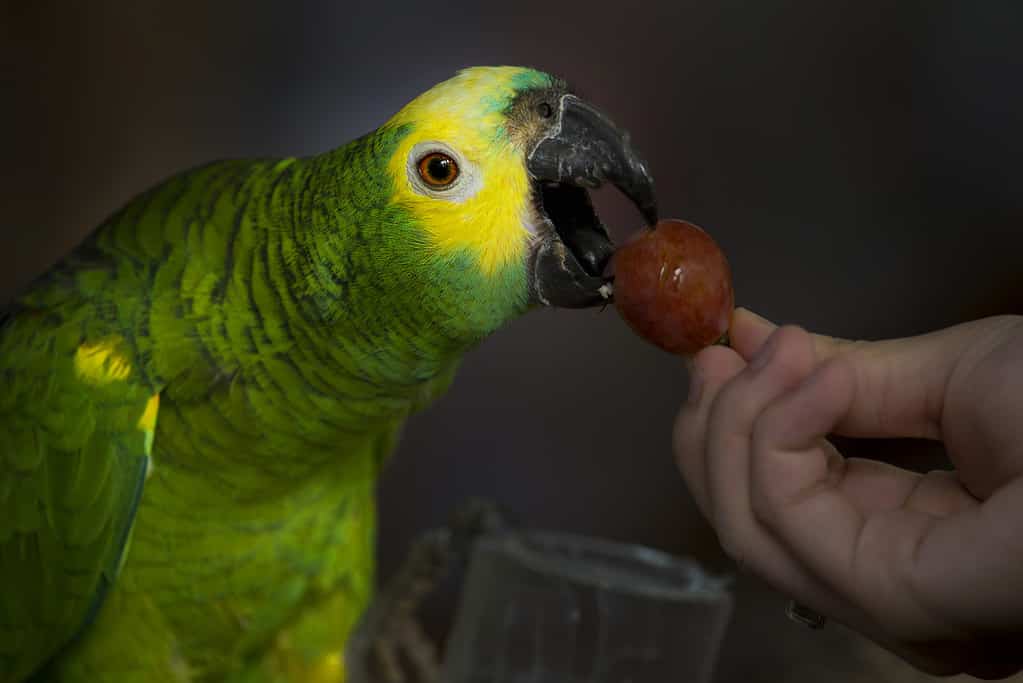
[0,66,657,683]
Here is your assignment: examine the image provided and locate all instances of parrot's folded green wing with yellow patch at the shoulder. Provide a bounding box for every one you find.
[0,307,159,683]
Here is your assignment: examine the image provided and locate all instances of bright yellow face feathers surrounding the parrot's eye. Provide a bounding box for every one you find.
[389,66,544,275]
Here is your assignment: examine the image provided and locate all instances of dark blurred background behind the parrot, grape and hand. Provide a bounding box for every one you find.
[6,0,1023,683]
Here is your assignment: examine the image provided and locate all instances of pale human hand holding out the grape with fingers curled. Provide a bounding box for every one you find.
[675,310,1023,679]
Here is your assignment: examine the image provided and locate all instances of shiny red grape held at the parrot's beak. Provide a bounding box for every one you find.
[612,219,736,355]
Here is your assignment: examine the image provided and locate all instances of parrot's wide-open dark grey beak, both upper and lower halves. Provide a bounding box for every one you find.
[527,95,658,308]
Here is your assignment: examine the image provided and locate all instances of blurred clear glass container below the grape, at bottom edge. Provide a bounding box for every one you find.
[441,532,731,683]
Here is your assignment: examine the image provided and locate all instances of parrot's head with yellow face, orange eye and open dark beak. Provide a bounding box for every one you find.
[349,66,657,347]
